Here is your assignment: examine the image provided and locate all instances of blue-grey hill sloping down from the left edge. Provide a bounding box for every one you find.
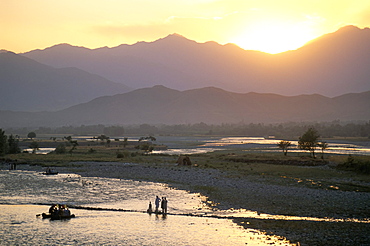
[0,51,130,111]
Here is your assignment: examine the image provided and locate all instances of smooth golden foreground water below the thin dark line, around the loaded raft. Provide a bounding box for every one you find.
[0,205,290,245]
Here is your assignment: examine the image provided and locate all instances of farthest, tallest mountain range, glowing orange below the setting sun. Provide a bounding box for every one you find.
[23,26,370,97]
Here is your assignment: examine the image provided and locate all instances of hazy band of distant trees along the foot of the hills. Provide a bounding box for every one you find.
[6,121,370,139]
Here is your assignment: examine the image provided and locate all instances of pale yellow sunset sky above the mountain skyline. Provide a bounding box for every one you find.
[0,0,370,53]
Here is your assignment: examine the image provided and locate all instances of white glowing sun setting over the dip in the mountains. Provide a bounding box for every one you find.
[231,21,314,54]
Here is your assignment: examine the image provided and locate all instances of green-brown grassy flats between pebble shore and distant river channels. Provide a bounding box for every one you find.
[6,140,370,192]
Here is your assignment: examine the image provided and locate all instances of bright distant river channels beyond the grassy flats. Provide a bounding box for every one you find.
[23,136,370,155]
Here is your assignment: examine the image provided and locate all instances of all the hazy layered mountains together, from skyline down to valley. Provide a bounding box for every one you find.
[0,26,370,127]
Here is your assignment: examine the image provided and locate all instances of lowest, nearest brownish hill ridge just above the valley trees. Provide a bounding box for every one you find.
[0,86,370,127]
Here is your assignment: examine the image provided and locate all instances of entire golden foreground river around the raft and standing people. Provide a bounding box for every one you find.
[0,168,291,245]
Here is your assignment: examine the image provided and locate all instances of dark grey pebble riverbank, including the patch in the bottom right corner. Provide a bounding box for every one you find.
[9,162,370,245]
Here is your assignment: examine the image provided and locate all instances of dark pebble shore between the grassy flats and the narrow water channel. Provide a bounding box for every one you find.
[64,162,370,219]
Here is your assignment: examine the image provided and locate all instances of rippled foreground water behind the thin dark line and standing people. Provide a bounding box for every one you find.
[0,170,205,213]
